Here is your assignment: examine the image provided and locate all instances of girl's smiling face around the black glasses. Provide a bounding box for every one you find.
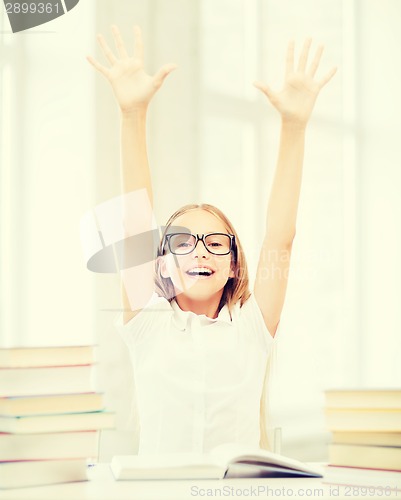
[161,209,234,301]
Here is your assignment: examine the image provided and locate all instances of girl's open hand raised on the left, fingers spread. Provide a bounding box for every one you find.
[87,25,177,114]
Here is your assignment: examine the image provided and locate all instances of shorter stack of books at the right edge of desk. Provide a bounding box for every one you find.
[325,389,401,489]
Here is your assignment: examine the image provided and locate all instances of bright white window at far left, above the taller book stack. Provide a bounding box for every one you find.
[0,2,94,345]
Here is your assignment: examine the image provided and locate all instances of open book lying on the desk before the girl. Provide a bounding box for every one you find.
[110,443,322,480]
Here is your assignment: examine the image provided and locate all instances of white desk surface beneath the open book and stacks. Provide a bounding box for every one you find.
[0,464,401,500]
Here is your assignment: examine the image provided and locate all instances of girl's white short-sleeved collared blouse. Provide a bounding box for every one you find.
[117,295,274,454]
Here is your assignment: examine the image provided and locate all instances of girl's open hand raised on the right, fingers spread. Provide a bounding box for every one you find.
[254,38,337,125]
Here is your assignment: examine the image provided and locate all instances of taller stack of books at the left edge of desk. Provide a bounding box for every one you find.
[0,346,114,488]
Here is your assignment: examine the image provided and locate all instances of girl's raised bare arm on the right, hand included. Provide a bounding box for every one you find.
[254,40,336,337]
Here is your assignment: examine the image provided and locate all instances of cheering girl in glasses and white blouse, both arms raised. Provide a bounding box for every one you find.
[88,26,336,453]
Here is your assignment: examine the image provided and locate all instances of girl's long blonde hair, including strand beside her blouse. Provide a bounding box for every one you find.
[155,203,272,449]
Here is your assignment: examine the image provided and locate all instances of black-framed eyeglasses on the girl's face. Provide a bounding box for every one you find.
[163,233,235,255]
